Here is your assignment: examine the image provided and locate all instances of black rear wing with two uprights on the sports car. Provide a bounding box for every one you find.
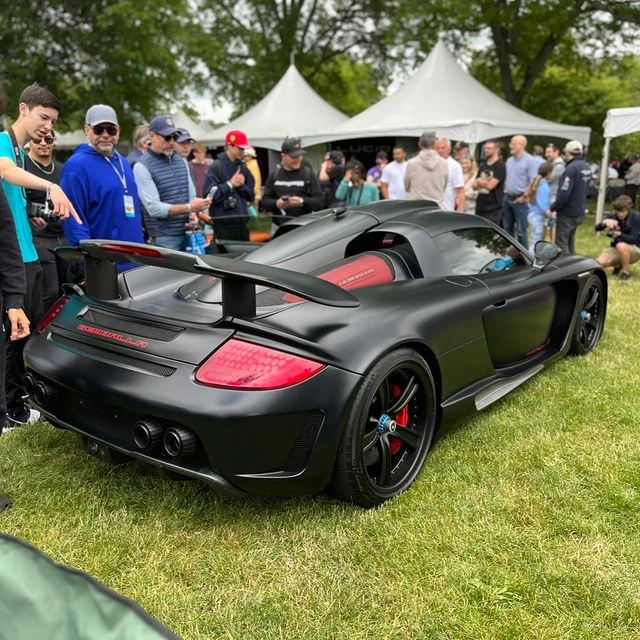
[56,240,359,317]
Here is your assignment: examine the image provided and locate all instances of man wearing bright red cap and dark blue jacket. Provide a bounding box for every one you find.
[204,131,255,241]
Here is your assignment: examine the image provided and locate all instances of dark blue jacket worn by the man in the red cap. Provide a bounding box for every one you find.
[204,151,256,224]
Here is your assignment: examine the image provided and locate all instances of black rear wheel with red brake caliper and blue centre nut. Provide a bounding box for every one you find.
[330,349,436,507]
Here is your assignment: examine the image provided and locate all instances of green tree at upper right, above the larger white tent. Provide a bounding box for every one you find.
[397,0,640,106]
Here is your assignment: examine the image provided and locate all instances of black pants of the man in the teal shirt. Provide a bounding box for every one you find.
[0,262,42,417]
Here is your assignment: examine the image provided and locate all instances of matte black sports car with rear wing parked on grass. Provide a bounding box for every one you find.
[26,201,607,506]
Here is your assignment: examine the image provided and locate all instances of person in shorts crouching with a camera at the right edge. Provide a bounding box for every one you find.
[596,196,640,281]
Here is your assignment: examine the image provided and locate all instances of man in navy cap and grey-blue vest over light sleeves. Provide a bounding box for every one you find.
[133,116,211,251]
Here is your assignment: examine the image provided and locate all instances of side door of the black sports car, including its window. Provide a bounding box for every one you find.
[435,227,557,367]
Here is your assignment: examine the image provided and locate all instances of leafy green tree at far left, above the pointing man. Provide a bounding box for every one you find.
[0,0,205,135]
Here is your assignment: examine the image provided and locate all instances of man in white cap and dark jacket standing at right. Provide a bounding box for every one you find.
[547,140,591,254]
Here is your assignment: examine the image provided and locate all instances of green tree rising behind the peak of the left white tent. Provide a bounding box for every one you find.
[198,0,388,113]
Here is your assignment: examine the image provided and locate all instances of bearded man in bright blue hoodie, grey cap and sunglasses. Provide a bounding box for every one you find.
[60,104,144,250]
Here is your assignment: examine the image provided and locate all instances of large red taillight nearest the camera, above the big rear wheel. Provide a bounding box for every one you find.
[196,339,325,390]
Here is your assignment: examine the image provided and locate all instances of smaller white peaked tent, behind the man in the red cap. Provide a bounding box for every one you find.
[202,65,347,151]
